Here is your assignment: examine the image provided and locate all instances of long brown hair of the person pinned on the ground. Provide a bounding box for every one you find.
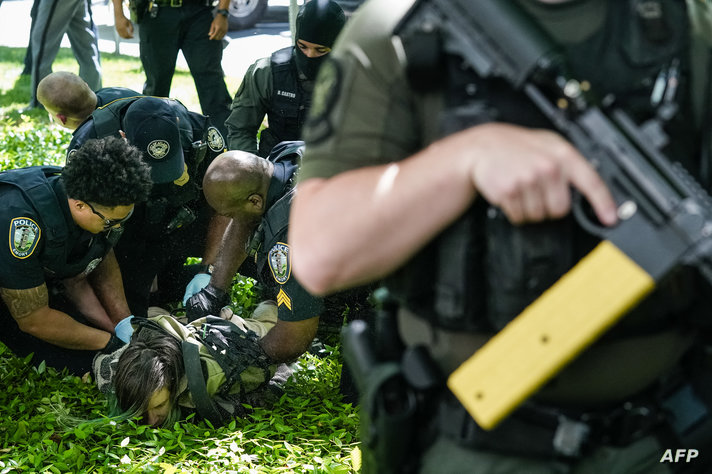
[113,328,185,426]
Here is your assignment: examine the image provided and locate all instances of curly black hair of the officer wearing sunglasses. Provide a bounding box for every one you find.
[61,137,152,207]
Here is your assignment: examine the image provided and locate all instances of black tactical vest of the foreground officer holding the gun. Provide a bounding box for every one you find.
[387,0,700,337]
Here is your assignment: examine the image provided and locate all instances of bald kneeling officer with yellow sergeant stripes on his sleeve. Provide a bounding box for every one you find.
[181,142,323,362]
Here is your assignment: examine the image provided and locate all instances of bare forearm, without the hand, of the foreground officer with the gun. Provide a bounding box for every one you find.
[289,134,475,294]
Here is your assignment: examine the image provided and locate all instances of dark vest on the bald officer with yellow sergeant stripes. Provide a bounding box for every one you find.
[247,141,304,282]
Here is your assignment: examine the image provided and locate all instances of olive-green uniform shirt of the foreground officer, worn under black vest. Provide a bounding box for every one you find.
[299,0,712,181]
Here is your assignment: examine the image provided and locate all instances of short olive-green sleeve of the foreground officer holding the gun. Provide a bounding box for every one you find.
[299,0,422,180]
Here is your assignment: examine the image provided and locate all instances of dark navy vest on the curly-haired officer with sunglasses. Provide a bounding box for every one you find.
[0,166,120,278]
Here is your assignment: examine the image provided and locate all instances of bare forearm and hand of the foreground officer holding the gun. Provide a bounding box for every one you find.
[290,123,617,294]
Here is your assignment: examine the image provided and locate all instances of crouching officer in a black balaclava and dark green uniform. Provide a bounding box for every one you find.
[225,0,346,157]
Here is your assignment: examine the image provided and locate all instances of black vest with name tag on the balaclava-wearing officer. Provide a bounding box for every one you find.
[259,46,311,157]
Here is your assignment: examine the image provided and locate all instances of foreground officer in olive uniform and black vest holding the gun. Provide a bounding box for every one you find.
[290,0,712,473]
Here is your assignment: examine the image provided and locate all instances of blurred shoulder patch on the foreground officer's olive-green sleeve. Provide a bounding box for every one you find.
[308,55,341,142]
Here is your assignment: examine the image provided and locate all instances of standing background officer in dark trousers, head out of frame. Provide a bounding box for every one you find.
[112,0,230,135]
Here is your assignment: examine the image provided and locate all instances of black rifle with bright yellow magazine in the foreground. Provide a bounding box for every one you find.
[412,0,712,429]
